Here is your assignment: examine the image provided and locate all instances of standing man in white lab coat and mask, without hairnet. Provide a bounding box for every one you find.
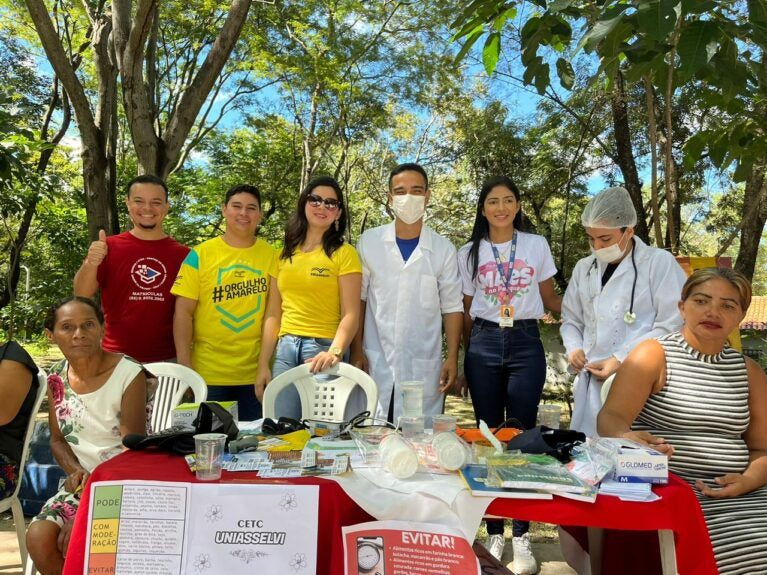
[351,164,463,422]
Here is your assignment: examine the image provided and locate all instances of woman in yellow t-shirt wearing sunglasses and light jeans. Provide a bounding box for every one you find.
[256,176,362,419]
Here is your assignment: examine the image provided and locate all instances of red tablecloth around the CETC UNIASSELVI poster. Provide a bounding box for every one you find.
[64,451,373,575]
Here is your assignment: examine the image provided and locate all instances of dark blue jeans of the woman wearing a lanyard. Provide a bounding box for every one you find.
[464,318,546,537]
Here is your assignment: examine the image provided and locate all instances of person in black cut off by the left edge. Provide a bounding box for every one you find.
[0,341,38,499]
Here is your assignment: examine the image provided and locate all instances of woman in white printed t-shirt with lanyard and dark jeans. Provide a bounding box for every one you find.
[458,176,561,575]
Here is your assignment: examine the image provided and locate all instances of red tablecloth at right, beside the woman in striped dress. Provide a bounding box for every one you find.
[487,474,718,575]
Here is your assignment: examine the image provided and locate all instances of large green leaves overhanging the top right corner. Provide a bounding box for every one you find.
[452,0,767,180]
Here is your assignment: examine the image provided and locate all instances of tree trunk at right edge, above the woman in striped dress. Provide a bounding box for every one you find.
[735,161,767,279]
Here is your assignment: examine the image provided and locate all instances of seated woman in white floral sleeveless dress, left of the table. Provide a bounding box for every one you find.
[27,296,147,575]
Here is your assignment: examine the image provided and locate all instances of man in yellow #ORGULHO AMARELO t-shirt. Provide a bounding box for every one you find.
[171,185,278,421]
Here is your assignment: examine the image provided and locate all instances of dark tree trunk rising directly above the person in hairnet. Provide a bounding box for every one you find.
[610,72,650,244]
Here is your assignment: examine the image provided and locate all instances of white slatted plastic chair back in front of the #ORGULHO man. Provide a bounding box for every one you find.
[144,362,208,432]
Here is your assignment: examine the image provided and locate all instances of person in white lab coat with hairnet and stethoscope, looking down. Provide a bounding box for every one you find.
[560,187,687,437]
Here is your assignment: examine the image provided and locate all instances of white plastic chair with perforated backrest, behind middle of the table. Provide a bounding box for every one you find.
[262,363,378,421]
